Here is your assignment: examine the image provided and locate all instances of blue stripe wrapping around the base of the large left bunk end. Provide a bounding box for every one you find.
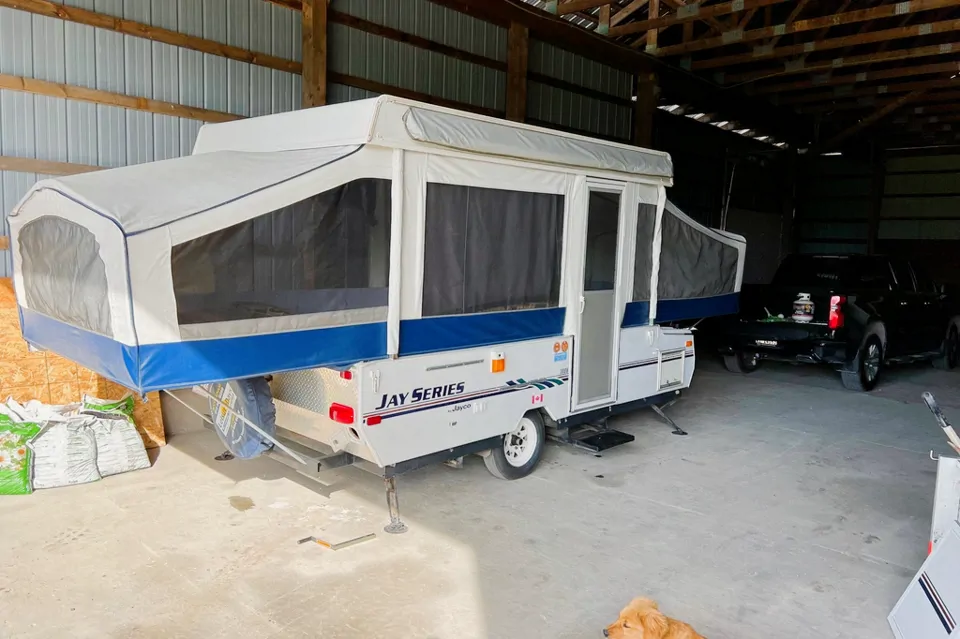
[20,308,387,393]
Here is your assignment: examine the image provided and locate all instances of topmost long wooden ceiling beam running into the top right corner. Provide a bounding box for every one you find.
[656,0,960,56]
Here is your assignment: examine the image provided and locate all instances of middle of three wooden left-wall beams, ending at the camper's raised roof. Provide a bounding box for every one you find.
[0,73,242,122]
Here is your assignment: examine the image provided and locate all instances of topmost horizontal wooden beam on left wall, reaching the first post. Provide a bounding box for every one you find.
[0,0,300,73]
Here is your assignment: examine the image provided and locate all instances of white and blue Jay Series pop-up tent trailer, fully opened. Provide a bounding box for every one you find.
[10,96,745,524]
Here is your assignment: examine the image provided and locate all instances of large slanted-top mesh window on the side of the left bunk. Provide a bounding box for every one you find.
[172,178,390,325]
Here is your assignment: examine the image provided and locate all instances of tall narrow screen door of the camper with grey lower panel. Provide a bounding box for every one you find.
[574,186,623,409]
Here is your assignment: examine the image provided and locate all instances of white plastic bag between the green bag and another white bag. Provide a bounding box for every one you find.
[28,418,100,489]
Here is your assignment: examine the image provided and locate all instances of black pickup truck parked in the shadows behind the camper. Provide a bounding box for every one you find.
[719,255,960,391]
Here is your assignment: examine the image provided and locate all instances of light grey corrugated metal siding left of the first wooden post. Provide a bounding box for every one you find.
[0,0,300,277]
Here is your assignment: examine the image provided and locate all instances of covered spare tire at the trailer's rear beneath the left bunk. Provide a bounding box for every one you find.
[209,377,277,459]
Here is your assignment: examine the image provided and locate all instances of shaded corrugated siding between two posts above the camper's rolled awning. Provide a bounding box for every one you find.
[527,39,633,140]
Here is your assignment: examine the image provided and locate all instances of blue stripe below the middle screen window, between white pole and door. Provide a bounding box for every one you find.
[400,308,564,355]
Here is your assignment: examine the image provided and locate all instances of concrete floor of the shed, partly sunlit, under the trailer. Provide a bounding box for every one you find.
[0,362,960,639]
